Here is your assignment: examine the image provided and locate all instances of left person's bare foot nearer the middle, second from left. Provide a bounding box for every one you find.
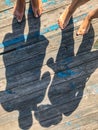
[31,0,43,18]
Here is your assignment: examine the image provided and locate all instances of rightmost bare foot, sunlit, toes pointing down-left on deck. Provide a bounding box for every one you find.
[76,16,91,36]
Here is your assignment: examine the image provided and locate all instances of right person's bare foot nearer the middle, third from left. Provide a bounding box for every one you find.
[58,6,72,29]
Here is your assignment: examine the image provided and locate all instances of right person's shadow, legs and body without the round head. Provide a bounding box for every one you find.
[48,19,98,118]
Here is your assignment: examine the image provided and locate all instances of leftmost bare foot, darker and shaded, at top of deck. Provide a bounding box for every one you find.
[13,0,25,22]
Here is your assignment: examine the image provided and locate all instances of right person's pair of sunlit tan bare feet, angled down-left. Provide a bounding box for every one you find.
[58,6,98,36]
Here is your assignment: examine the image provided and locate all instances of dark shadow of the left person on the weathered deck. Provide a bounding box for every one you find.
[0,2,50,130]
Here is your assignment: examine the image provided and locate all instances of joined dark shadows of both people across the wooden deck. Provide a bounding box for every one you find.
[0,5,98,130]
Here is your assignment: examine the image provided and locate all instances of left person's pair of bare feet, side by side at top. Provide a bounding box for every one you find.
[13,0,43,22]
